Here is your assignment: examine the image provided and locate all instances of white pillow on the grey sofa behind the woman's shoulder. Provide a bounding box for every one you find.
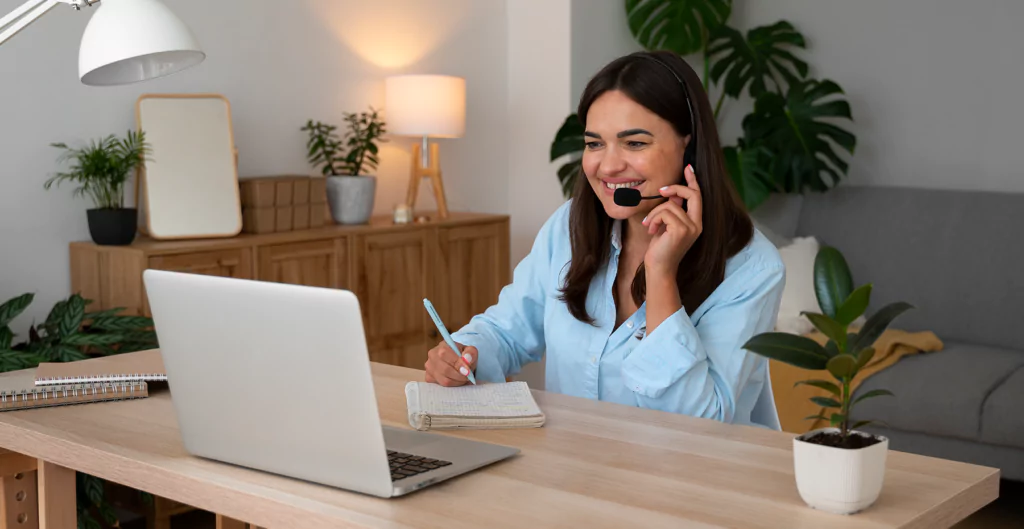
[775,237,821,335]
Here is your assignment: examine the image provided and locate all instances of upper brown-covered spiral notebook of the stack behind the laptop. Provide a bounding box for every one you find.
[36,349,167,386]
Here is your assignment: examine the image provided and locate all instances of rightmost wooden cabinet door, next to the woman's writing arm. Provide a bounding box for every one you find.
[434,222,509,333]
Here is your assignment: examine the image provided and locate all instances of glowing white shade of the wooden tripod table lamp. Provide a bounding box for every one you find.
[384,75,466,138]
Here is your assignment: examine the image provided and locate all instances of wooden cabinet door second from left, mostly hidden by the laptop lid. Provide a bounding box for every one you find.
[256,239,347,289]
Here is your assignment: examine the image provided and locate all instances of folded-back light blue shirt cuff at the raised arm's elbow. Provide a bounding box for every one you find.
[622,308,708,399]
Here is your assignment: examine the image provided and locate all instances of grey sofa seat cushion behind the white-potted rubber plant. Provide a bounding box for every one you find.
[851,342,1024,440]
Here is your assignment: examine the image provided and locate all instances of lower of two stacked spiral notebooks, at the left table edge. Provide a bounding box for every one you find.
[0,369,150,411]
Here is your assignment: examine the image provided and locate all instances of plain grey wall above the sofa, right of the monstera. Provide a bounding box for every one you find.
[737,0,1024,192]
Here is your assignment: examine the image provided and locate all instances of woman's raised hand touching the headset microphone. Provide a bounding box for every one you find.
[643,166,703,277]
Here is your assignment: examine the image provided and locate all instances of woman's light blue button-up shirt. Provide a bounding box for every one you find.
[453,201,785,426]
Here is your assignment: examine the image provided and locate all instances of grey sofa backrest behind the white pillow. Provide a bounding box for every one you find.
[798,185,1024,348]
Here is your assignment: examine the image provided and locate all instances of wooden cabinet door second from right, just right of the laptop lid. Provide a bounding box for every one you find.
[352,229,428,369]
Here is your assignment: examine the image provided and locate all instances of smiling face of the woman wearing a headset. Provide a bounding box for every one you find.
[583,90,689,221]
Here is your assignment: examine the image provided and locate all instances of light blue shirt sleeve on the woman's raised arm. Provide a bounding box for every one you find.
[622,263,785,423]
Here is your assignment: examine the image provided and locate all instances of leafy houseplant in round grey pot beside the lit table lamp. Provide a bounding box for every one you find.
[302,107,387,224]
